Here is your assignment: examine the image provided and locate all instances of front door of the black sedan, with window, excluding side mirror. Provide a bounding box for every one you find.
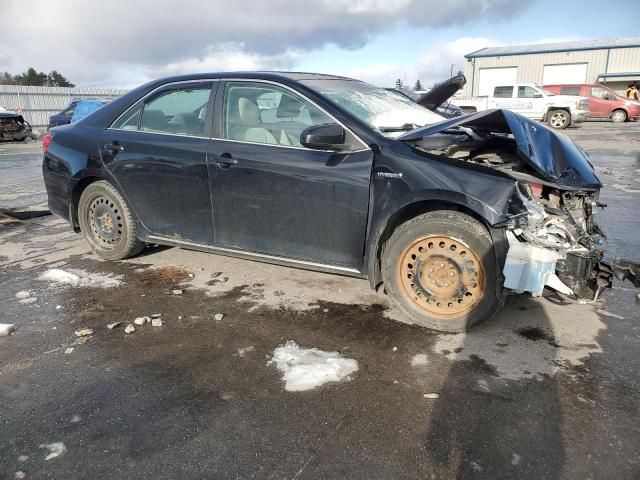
[208,81,373,270]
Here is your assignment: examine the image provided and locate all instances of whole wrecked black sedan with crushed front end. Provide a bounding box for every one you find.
[43,72,610,331]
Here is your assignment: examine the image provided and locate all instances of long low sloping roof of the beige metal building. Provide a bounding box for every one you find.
[465,37,640,58]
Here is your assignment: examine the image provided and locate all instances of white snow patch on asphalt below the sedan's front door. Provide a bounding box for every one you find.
[268,340,358,392]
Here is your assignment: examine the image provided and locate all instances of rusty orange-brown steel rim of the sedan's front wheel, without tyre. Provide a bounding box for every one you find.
[397,235,486,319]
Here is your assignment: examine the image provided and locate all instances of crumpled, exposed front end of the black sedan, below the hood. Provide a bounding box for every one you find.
[503,182,614,300]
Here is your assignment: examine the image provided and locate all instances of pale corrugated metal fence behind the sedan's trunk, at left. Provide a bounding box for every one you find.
[0,85,127,127]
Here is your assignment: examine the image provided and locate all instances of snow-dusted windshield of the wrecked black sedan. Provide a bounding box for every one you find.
[300,79,444,137]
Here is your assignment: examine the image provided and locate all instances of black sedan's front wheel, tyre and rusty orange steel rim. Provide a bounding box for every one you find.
[382,211,500,332]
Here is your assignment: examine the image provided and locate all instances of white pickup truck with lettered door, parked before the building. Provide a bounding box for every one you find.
[455,83,589,129]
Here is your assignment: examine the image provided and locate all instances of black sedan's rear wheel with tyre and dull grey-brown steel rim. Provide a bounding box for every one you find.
[78,180,144,260]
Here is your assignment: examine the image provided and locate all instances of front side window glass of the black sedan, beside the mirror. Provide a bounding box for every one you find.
[222,82,335,147]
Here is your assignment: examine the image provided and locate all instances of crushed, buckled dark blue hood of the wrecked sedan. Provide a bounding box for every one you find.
[398,109,602,190]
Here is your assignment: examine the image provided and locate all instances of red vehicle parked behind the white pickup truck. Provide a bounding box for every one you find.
[544,83,640,122]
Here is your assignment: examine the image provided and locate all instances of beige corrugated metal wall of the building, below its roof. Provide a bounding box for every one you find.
[464,48,640,95]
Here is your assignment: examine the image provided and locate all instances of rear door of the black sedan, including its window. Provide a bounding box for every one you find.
[101,81,216,245]
